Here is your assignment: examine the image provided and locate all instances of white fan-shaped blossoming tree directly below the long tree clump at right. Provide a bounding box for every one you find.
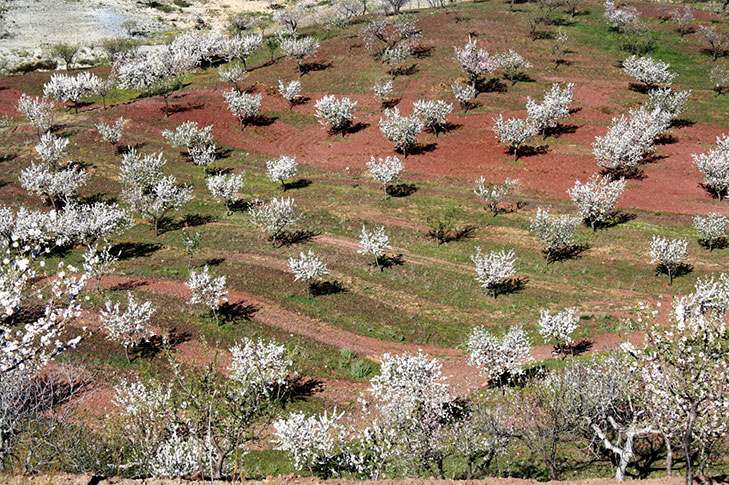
[567,175,625,231]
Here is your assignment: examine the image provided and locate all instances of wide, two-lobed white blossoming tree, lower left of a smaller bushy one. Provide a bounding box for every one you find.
[466,326,534,381]
